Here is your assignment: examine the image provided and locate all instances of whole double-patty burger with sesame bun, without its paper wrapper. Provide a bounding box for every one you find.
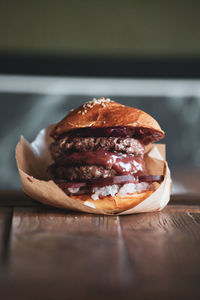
[47,98,164,212]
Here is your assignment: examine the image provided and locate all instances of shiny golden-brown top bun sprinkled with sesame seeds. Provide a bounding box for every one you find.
[51,98,164,139]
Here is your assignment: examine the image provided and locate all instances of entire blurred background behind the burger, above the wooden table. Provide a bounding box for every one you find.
[0,0,200,194]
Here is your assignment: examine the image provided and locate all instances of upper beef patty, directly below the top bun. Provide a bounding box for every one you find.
[50,136,144,161]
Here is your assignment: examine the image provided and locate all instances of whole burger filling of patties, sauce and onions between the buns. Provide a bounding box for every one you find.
[48,128,163,200]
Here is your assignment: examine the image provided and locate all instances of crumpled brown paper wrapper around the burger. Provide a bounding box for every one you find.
[16,124,171,215]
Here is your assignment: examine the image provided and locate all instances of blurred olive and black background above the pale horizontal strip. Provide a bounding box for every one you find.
[0,0,200,78]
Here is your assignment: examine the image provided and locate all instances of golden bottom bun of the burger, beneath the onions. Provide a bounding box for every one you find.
[70,190,154,214]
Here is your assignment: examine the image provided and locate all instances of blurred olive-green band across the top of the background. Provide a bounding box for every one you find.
[0,0,200,58]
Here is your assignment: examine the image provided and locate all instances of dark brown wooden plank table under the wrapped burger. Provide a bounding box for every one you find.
[0,192,200,300]
